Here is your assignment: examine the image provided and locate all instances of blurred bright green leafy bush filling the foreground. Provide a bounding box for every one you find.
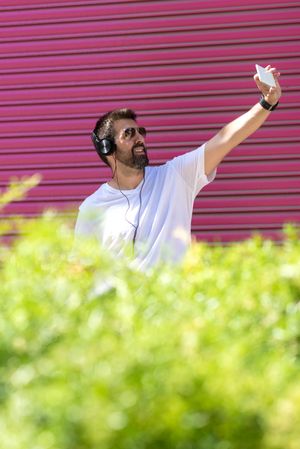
[0,213,300,449]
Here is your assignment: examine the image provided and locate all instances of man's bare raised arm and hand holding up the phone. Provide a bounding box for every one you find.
[205,65,281,175]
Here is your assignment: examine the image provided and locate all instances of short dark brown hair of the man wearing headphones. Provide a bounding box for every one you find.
[94,108,137,167]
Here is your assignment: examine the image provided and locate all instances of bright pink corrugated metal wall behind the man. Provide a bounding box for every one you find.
[0,0,300,242]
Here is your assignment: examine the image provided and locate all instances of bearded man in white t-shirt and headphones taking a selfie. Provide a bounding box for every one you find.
[75,66,281,270]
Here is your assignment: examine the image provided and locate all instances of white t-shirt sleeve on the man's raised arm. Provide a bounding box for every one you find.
[169,144,216,196]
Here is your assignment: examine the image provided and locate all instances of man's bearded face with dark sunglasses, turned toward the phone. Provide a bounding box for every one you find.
[114,119,149,170]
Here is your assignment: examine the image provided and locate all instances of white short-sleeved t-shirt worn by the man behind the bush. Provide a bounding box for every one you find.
[75,144,216,270]
